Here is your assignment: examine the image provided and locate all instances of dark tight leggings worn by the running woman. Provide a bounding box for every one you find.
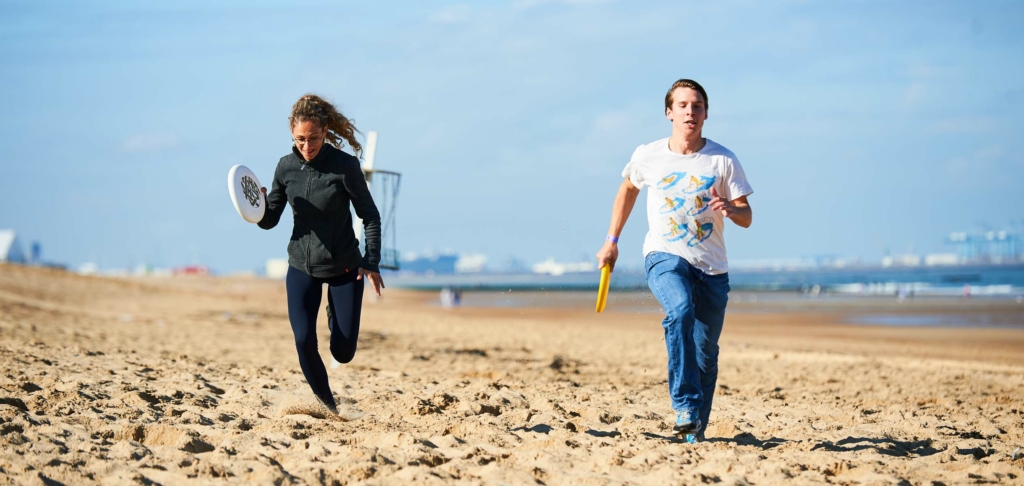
[285,267,364,406]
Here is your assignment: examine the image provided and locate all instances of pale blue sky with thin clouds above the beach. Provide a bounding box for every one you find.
[0,0,1024,272]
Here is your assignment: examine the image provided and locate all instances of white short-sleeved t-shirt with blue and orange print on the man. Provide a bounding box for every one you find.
[623,138,754,275]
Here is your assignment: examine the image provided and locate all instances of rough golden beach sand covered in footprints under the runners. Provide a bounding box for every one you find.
[0,265,1024,485]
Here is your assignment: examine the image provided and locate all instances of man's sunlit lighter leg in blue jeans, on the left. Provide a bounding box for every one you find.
[646,252,702,418]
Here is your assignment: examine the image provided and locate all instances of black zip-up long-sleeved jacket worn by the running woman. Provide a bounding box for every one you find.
[257,143,381,278]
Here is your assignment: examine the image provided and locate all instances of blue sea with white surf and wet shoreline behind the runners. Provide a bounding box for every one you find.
[384,264,1024,329]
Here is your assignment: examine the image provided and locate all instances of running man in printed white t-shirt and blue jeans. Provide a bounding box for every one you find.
[597,79,754,442]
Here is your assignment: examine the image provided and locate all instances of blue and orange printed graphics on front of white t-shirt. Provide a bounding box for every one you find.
[656,172,716,248]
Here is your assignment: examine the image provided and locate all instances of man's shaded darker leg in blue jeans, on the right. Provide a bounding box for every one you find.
[693,268,729,435]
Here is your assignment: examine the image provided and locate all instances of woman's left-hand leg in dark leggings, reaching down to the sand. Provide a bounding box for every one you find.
[285,267,336,407]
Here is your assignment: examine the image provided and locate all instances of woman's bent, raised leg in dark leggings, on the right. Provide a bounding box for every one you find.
[327,270,365,363]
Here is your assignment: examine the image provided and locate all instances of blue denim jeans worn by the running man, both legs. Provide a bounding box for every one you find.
[644,252,729,427]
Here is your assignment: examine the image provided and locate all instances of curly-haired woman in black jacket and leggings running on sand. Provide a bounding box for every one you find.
[258,94,384,413]
